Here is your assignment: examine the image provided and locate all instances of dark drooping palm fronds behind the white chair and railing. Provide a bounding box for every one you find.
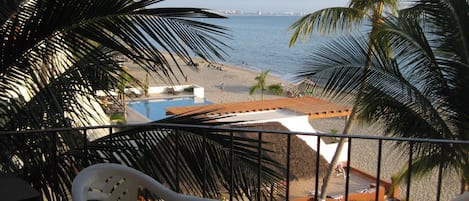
[0,114,284,200]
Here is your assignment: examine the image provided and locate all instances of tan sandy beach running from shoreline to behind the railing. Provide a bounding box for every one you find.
[126,56,459,200]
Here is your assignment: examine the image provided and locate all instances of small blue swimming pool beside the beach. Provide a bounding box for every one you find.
[127,98,213,121]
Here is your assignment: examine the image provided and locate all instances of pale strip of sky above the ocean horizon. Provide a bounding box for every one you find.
[157,0,349,13]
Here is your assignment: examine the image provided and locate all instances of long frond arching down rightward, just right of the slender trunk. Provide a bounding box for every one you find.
[372,15,467,138]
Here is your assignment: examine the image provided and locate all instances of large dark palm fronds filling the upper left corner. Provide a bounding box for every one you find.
[0,0,227,128]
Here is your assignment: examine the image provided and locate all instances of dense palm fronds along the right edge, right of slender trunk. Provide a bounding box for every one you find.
[292,0,469,198]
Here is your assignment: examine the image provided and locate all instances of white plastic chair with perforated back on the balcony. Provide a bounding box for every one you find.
[72,163,218,201]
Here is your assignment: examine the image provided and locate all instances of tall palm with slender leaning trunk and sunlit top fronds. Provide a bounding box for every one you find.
[290,0,398,199]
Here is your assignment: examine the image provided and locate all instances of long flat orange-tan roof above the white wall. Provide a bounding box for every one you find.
[166,97,351,119]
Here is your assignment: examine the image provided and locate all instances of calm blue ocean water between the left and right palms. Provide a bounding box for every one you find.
[207,16,325,80]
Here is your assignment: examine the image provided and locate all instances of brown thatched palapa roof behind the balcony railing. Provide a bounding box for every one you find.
[232,122,328,179]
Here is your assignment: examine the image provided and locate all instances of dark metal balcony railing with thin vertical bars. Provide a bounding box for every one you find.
[0,122,469,200]
